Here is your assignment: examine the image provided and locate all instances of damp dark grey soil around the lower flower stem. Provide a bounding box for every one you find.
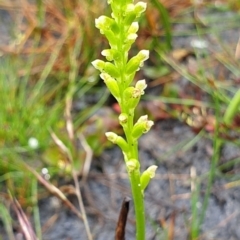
[29,120,240,240]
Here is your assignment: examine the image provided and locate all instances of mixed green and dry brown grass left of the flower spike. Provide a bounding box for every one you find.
[0,1,108,239]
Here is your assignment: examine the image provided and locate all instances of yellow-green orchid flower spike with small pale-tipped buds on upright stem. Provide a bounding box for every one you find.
[92,0,157,240]
